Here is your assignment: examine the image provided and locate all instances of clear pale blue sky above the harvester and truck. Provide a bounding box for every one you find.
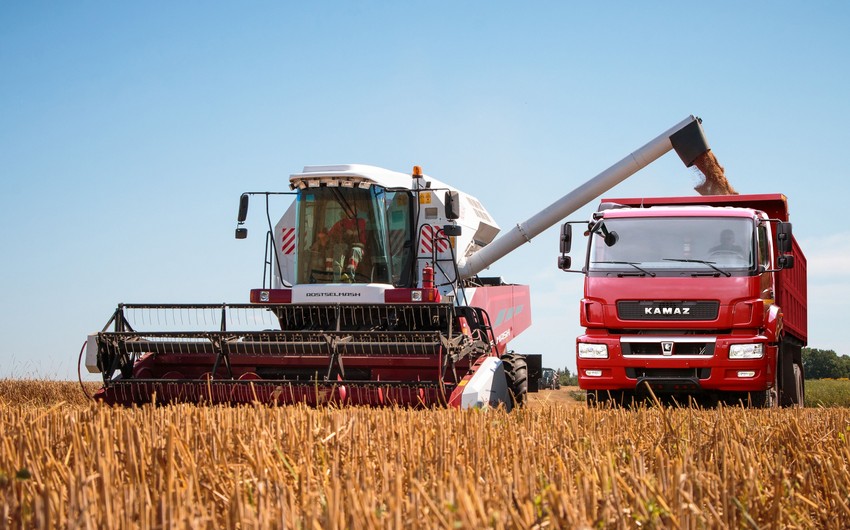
[0,1,850,379]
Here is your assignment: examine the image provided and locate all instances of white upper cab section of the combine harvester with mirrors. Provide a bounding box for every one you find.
[242,165,499,303]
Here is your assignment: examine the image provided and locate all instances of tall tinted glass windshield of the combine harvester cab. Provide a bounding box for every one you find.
[296,186,411,285]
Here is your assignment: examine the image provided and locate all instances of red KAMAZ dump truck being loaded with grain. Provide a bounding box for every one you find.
[559,194,807,407]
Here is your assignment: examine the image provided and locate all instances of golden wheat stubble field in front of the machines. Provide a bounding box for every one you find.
[0,381,850,529]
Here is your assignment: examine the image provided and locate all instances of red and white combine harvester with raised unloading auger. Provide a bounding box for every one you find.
[81,116,708,408]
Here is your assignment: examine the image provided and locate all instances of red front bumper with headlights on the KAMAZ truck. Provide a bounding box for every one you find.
[576,335,777,393]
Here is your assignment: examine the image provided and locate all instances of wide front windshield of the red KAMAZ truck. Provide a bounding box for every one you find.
[588,217,755,276]
